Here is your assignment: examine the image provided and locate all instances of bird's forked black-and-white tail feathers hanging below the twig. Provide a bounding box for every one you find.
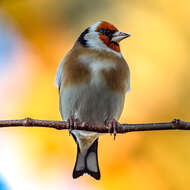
[73,135,100,180]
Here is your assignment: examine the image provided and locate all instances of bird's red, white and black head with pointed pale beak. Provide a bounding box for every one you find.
[77,21,130,53]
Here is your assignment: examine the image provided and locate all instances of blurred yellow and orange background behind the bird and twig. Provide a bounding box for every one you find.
[0,0,190,190]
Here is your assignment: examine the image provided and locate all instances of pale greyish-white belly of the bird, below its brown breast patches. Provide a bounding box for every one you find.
[60,84,124,124]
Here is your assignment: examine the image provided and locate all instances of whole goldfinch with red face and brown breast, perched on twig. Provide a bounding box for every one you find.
[56,21,130,179]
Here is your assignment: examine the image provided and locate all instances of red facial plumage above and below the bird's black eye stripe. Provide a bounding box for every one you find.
[96,21,120,52]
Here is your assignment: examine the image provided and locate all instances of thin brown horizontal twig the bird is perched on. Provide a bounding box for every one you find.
[0,118,190,133]
